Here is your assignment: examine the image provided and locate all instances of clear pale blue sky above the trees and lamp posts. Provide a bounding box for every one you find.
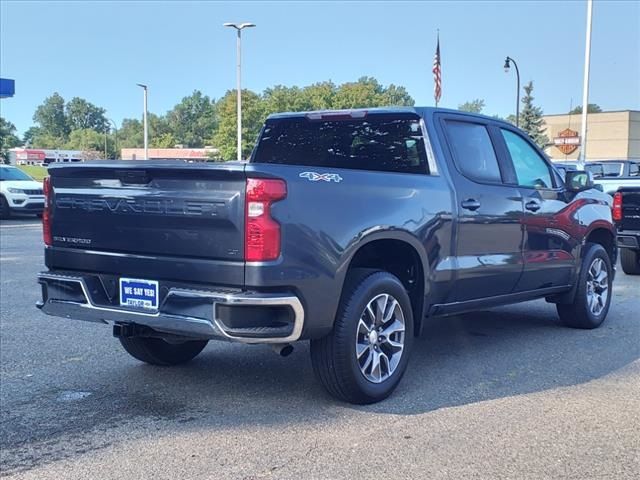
[0,0,640,134]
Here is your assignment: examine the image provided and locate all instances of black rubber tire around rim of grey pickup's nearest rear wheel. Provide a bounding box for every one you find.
[311,269,413,404]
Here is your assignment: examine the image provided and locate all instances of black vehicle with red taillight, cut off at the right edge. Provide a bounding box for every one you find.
[613,185,640,275]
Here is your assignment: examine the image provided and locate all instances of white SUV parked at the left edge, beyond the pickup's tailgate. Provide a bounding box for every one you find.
[0,165,44,218]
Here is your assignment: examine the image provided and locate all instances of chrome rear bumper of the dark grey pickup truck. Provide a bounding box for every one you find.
[37,272,305,343]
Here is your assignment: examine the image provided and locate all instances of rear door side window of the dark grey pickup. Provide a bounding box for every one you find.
[446,120,502,183]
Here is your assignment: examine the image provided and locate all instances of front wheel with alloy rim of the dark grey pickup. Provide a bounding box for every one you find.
[556,243,613,328]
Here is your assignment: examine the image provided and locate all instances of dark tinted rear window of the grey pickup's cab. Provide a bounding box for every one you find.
[252,114,428,173]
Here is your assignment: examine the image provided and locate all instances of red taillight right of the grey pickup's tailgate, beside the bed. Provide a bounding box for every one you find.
[244,178,287,262]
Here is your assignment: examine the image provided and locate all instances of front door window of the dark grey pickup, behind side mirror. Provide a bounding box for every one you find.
[501,129,554,188]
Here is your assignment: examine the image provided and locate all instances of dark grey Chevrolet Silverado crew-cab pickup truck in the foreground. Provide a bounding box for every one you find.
[38,108,617,403]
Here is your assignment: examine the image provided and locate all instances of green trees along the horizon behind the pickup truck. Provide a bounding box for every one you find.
[0,77,584,161]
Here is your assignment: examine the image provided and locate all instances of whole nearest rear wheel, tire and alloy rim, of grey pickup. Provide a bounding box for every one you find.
[311,269,413,404]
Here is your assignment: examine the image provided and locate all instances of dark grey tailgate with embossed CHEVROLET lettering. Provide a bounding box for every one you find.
[50,161,246,262]
